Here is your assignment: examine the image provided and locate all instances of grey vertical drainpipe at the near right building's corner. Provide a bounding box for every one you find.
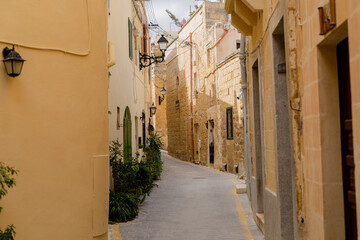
[240,35,251,189]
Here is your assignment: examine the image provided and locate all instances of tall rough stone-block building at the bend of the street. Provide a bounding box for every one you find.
[166,2,244,173]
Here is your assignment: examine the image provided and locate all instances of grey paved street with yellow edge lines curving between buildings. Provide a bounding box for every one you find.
[109,154,263,240]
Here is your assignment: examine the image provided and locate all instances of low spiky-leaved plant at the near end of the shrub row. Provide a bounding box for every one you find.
[109,190,139,222]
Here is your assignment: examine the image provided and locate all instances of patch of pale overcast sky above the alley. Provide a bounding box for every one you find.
[152,0,202,31]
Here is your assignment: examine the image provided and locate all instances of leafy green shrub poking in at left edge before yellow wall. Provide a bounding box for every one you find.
[0,162,18,240]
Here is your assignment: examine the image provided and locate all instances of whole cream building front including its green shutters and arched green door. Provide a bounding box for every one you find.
[108,0,151,161]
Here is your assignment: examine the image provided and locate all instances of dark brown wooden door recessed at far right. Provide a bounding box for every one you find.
[337,39,357,239]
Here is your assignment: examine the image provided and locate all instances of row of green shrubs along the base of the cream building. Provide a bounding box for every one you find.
[108,133,162,223]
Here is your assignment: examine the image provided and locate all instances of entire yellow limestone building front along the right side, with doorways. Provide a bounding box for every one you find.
[226,0,360,239]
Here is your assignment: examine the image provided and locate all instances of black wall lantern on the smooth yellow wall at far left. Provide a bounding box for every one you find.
[2,46,25,77]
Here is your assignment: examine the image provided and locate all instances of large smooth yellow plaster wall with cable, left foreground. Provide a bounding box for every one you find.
[0,0,108,240]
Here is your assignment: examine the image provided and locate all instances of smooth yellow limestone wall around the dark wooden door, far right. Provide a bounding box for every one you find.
[298,0,360,239]
